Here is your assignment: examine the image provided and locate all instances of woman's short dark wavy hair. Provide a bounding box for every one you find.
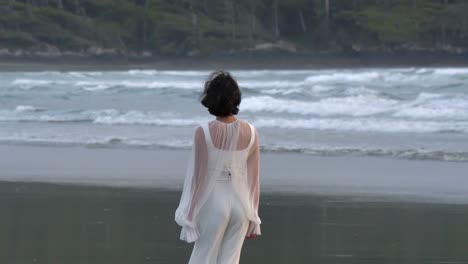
[200,71,242,116]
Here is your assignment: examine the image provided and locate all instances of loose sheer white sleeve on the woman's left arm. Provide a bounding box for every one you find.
[175,127,208,243]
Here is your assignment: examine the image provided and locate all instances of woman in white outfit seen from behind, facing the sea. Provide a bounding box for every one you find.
[175,71,261,264]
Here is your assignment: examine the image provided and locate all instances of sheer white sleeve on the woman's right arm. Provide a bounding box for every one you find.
[247,129,261,236]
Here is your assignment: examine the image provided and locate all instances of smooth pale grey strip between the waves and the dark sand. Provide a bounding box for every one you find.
[0,145,468,204]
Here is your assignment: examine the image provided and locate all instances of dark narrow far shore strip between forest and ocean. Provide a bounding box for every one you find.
[0,53,468,72]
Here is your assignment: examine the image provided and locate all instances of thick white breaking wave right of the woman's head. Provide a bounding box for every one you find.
[241,90,468,120]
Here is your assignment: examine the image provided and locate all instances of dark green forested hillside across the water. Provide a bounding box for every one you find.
[0,0,468,56]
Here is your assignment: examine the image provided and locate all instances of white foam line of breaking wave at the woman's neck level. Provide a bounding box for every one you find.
[92,111,468,133]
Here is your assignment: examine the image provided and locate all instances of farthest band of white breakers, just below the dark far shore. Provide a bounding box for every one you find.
[4,68,468,95]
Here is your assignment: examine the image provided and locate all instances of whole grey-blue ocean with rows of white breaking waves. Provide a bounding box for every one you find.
[0,68,468,162]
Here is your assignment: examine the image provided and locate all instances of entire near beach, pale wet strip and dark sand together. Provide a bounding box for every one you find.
[0,145,468,264]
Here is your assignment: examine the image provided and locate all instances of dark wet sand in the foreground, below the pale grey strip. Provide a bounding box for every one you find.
[0,182,468,264]
